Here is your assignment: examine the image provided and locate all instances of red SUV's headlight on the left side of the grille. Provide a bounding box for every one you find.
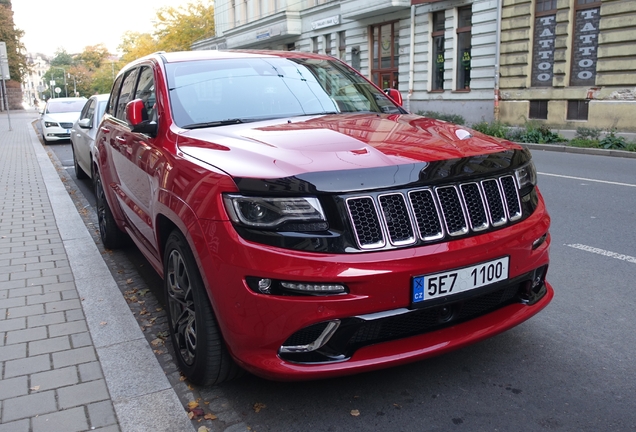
[223,195,328,231]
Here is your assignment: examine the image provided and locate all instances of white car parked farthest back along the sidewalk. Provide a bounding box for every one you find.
[40,97,86,143]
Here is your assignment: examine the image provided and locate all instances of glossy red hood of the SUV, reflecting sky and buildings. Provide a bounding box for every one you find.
[177,114,527,192]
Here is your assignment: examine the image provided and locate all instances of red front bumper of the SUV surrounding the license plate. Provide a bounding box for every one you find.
[198,200,554,380]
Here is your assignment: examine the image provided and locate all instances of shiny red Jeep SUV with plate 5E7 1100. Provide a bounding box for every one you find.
[94,51,553,385]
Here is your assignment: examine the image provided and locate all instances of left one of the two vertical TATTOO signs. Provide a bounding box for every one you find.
[532,15,556,87]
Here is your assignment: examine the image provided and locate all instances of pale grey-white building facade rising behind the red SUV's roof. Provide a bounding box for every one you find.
[192,0,500,123]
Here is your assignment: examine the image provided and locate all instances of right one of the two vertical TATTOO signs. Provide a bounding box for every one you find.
[570,8,601,86]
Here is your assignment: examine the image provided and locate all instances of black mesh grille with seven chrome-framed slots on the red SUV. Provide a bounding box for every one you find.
[346,175,522,250]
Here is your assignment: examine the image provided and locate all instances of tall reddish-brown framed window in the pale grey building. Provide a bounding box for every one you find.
[370,22,399,89]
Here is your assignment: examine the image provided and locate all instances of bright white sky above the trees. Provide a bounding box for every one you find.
[11,0,193,57]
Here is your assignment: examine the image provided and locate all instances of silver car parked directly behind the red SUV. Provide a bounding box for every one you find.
[71,94,109,179]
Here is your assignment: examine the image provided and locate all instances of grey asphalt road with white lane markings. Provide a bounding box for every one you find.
[49,139,636,432]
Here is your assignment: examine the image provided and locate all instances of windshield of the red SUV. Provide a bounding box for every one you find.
[166,57,402,127]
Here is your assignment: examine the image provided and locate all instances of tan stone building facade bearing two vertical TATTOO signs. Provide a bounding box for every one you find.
[499,0,636,131]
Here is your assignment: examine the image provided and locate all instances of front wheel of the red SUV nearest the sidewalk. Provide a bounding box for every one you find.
[163,230,242,386]
